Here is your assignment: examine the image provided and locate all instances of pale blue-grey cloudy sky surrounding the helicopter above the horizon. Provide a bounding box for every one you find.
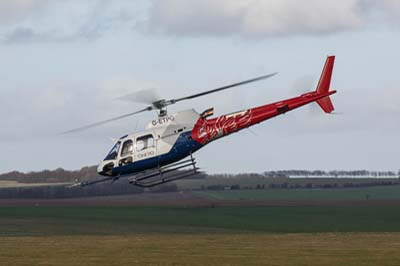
[0,0,400,173]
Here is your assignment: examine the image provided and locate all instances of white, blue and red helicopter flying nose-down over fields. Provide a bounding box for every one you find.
[62,56,336,188]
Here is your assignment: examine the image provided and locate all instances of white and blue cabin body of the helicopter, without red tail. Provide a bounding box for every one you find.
[97,110,199,176]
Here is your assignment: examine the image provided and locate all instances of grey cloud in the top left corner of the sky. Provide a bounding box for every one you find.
[0,0,134,44]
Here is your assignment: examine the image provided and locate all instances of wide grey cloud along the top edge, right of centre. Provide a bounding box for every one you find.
[145,0,400,37]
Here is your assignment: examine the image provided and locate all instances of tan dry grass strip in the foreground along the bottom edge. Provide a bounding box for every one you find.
[0,233,400,266]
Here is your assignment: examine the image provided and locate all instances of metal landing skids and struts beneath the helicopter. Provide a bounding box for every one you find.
[128,155,199,187]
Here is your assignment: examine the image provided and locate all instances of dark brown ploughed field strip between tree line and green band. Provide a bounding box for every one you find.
[0,191,400,207]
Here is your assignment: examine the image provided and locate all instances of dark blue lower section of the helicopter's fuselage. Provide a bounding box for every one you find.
[112,131,202,176]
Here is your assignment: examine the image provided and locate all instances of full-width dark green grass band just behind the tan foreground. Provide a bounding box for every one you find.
[0,206,400,236]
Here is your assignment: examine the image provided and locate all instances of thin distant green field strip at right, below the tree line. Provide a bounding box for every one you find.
[196,186,400,200]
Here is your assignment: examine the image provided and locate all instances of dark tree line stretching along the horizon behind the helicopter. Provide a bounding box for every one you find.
[0,166,400,199]
